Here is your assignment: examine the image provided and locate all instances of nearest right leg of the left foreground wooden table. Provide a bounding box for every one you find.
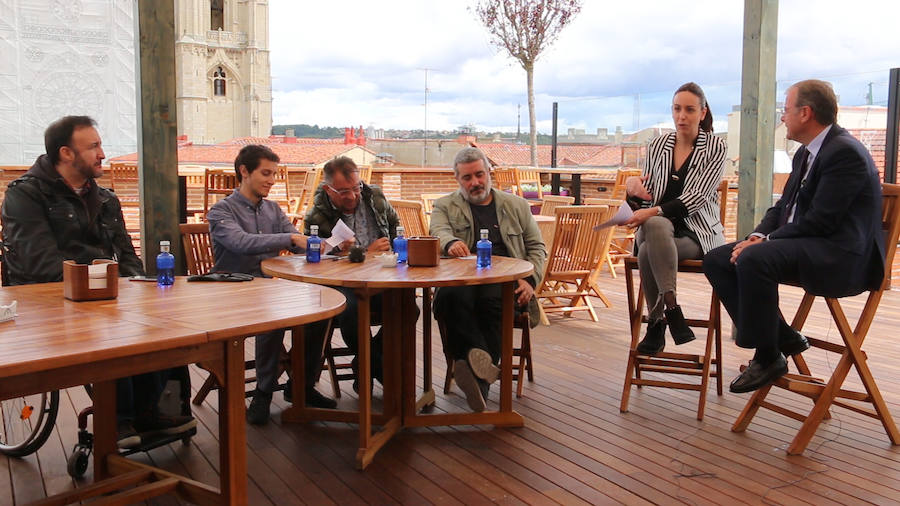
[219,339,247,505]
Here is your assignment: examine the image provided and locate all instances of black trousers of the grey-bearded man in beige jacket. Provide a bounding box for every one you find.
[433,284,524,364]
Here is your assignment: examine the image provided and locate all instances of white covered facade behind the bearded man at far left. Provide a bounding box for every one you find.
[0,0,137,165]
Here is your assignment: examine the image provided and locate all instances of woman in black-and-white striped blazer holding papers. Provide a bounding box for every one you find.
[625,83,727,355]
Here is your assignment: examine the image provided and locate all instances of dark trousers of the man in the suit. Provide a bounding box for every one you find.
[703,239,808,358]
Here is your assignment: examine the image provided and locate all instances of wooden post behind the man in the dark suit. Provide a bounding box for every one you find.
[737,0,778,239]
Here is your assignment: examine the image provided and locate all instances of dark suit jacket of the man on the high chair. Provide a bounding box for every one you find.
[755,124,884,297]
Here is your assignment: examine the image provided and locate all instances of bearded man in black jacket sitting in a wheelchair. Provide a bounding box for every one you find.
[0,116,197,448]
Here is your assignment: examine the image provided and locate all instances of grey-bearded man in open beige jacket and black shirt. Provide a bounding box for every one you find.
[430,148,547,411]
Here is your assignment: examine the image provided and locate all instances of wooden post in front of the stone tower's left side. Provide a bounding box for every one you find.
[134,0,184,274]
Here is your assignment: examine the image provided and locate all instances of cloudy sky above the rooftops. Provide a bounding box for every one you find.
[270,0,900,133]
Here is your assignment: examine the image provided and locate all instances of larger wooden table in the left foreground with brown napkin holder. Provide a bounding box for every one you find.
[0,277,345,505]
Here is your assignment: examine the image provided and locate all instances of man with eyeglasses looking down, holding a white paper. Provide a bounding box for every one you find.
[303,156,400,390]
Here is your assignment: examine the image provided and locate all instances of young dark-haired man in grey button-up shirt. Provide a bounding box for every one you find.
[207,145,337,425]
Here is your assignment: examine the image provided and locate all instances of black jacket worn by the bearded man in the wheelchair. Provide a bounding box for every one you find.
[0,155,144,285]
